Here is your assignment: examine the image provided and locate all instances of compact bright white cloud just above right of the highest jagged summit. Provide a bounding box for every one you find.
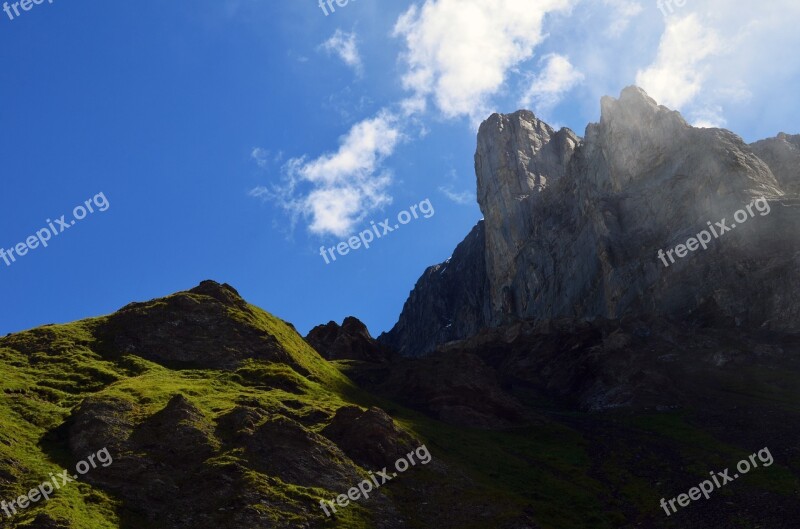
[636,14,724,108]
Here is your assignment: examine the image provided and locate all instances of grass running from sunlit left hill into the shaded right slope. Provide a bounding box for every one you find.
[0,296,798,529]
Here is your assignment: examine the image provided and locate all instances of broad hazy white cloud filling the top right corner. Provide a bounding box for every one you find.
[636,0,800,126]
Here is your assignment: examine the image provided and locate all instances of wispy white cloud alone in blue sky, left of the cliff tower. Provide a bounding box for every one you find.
[268,112,403,236]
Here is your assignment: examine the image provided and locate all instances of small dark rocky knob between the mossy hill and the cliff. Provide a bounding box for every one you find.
[305,316,392,362]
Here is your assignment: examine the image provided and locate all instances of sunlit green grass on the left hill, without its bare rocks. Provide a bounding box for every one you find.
[0,284,384,528]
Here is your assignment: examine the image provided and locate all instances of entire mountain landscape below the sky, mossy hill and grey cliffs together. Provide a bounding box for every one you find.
[0,88,800,529]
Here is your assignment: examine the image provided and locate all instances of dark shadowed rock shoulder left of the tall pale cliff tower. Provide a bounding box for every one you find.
[378,221,489,356]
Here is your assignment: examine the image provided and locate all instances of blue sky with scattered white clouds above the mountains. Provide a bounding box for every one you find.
[0,0,800,336]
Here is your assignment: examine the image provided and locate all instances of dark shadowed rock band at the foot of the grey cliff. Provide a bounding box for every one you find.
[434,318,800,411]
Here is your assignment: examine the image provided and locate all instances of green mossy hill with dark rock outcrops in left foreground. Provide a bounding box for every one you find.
[0,281,456,529]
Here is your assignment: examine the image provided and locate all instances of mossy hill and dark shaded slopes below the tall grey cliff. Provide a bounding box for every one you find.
[0,281,800,529]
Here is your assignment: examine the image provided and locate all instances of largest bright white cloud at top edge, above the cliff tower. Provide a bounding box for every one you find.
[394,0,573,119]
